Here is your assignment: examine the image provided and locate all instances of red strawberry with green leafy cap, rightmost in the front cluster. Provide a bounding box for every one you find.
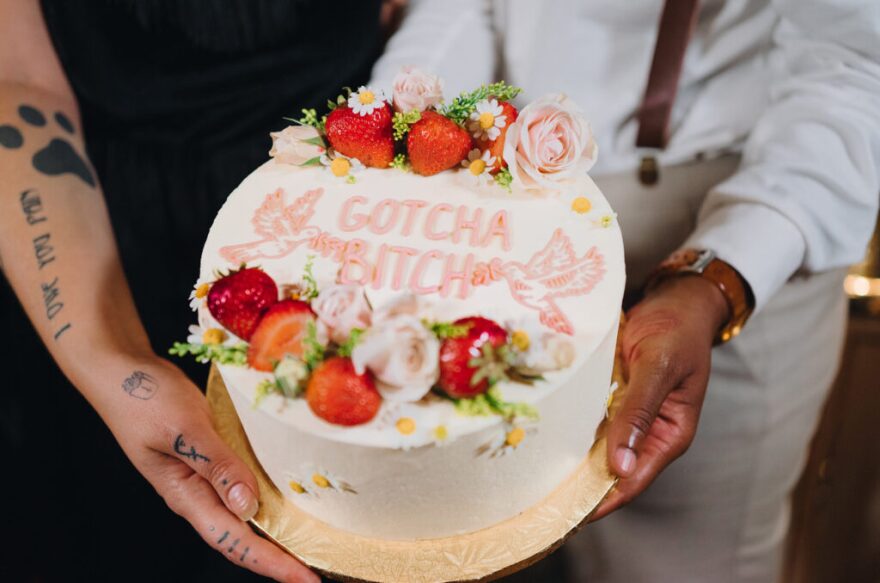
[439,316,507,398]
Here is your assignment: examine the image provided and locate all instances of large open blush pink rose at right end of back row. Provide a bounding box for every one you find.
[504,95,598,190]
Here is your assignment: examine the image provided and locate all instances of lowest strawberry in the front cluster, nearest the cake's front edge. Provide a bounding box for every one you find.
[306,356,382,425]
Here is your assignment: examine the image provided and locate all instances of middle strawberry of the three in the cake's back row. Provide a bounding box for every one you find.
[406,111,474,176]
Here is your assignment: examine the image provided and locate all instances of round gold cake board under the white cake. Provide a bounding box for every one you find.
[207,358,620,583]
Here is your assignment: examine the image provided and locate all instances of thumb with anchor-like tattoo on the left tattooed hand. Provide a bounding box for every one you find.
[166,423,260,520]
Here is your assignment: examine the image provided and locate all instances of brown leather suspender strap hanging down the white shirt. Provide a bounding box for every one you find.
[636,0,699,184]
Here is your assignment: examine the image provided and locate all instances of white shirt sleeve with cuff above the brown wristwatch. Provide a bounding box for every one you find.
[685,0,880,309]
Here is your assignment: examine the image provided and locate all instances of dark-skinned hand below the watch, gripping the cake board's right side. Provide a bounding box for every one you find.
[592,276,729,520]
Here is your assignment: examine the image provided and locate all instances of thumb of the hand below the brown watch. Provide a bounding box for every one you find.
[607,351,681,478]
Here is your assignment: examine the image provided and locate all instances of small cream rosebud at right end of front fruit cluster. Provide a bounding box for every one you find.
[507,320,575,375]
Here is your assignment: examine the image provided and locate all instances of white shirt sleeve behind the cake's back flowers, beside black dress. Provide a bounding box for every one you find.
[371,0,497,101]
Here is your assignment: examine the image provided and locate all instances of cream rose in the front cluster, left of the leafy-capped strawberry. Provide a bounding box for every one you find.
[351,314,440,402]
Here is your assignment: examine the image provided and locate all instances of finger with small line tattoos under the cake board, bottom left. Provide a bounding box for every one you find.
[157,462,320,583]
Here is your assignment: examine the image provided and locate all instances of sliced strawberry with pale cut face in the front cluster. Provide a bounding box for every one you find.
[248,300,315,372]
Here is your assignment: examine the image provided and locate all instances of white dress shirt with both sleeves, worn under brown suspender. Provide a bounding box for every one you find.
[373,0,880,309]
